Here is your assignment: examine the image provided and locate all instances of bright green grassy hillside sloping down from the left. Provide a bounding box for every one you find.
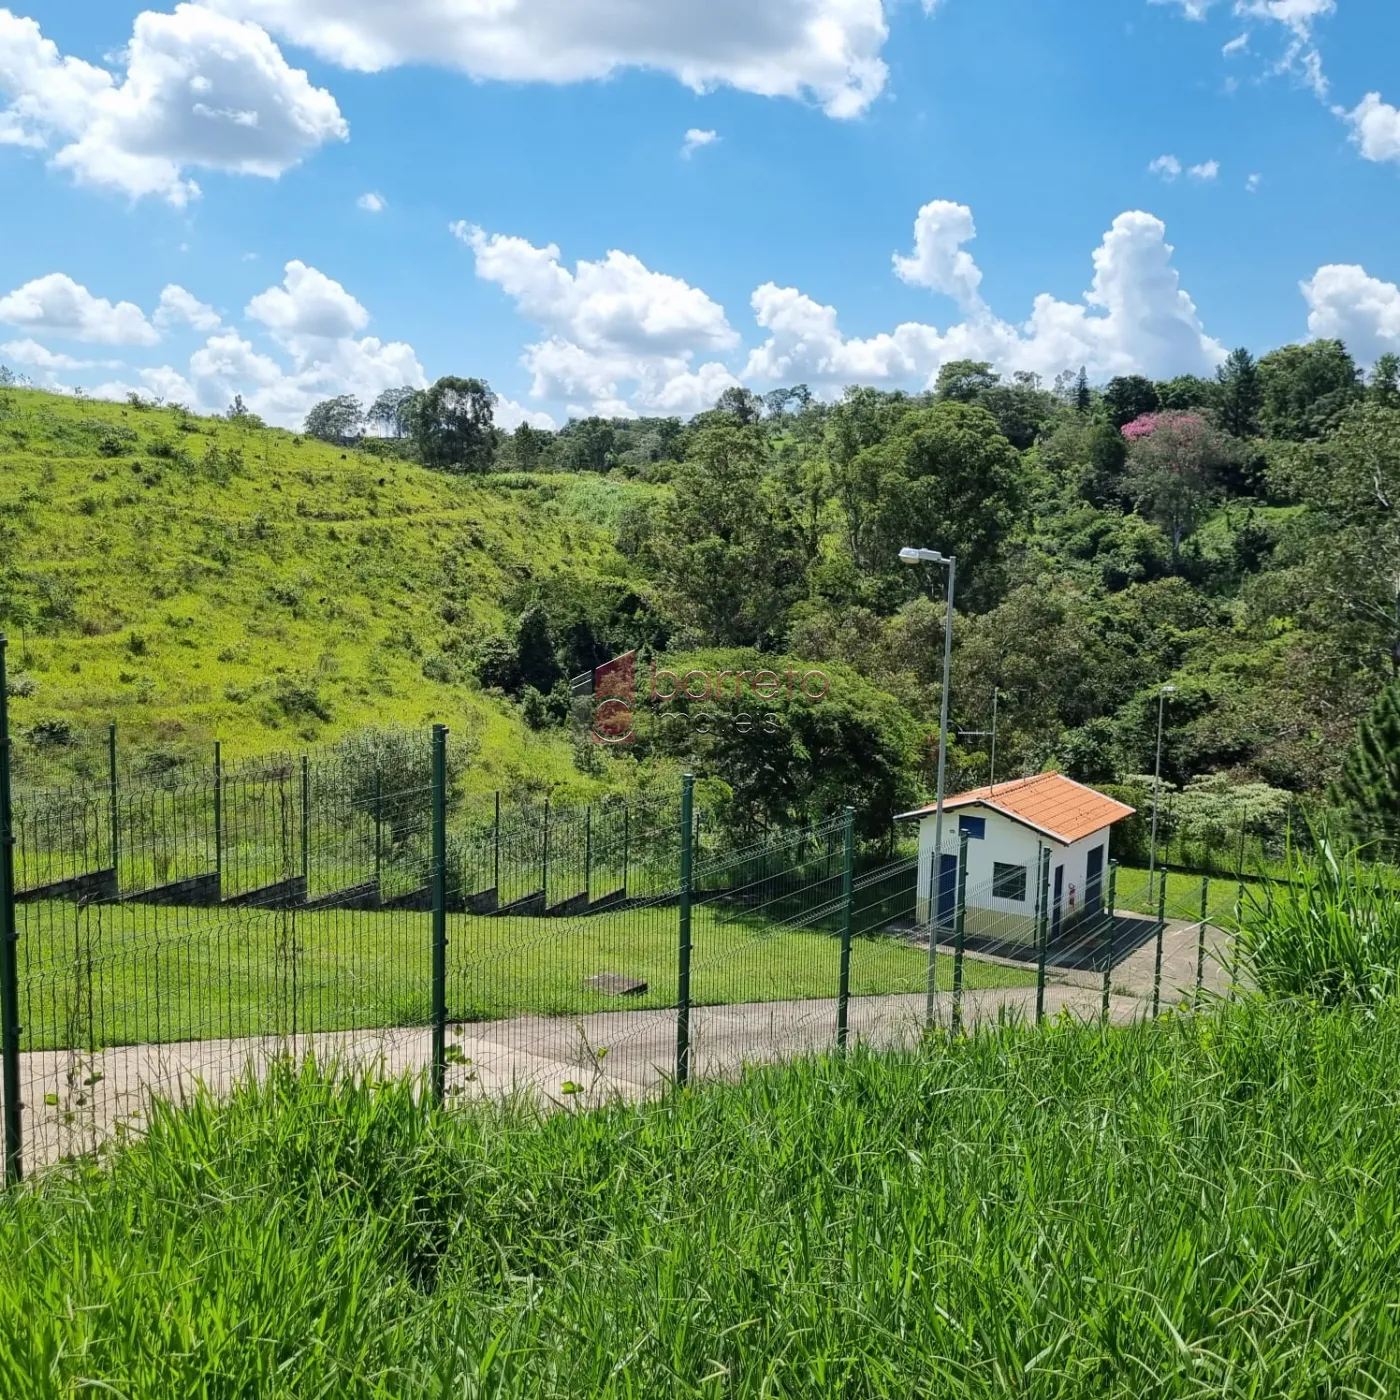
[0,391,647,787]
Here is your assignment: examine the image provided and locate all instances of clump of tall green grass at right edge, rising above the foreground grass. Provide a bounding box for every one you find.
[1238,833,1400,1004]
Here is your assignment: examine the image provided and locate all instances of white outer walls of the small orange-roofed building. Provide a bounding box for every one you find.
[917,806,1110,938]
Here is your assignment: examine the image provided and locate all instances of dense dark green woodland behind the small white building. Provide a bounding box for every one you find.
[307,340,1400,828]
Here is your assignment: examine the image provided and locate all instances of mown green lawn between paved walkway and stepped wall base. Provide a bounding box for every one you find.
[20,902,1035,1050]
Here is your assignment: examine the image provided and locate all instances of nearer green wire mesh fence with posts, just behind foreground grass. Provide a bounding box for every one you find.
[0,648,1254,1179]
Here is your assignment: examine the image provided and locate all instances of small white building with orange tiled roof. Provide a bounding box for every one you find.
[897,773,1134,942]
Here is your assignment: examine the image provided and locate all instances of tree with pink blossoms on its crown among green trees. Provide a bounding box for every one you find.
[1123,413,1236,567]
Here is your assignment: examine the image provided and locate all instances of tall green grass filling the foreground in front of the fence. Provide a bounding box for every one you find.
[0,998,1400,1400]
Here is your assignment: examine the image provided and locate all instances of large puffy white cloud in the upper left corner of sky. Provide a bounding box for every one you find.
[0,4,349,207]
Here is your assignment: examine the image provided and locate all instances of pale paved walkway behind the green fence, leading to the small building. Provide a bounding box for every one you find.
[10,924,1226,1169]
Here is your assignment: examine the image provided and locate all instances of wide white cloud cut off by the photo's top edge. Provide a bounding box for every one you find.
[206,0,889,118]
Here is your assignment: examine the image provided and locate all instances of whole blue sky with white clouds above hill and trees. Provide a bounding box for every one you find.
[0,0,1400,424]
